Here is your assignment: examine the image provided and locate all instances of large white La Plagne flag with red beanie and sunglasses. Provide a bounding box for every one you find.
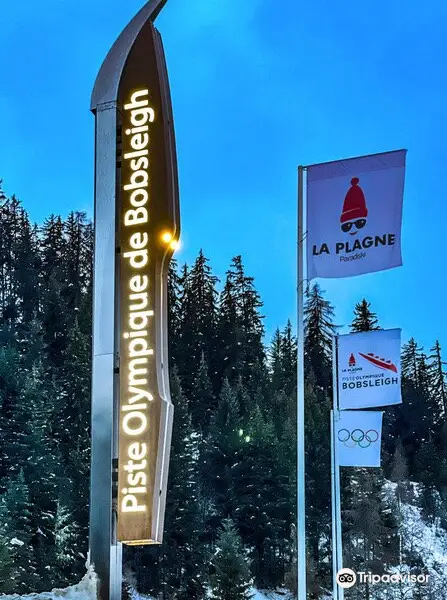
[307,150,407,281]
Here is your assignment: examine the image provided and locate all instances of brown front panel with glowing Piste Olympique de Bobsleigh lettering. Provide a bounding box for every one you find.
[117,22,179,544]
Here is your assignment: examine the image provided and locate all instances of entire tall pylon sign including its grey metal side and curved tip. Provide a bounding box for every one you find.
[91,0,180,552]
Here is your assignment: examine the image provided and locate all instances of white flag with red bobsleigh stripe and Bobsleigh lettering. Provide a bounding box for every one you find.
[337,329,402,410]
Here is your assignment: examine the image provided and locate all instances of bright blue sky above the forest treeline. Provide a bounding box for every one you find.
[0,0,447,356]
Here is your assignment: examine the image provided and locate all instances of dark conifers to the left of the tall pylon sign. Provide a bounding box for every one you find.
[0,193,93,593]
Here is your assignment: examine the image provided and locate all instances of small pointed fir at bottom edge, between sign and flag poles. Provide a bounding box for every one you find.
[211,519,253,600]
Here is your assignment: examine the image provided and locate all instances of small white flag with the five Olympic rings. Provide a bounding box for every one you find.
[334,410,383,467]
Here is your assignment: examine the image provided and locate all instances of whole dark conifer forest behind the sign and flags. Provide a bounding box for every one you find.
[0,186,447,600]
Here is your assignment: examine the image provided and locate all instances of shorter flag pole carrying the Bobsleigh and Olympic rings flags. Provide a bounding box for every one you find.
[331,335,345,600]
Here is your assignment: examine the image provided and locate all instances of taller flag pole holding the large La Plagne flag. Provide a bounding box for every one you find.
[296,166,307,600]
